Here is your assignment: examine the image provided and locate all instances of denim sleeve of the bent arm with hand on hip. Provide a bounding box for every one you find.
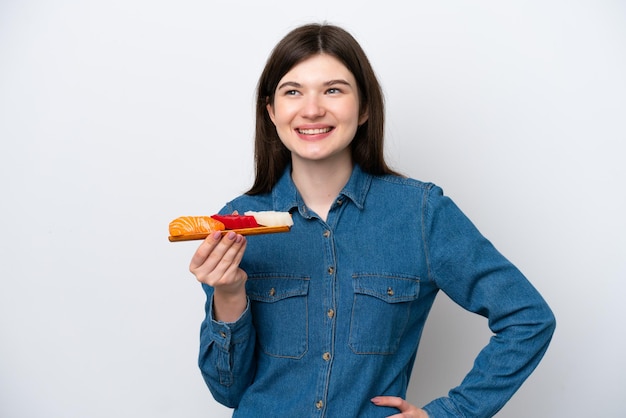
[422,186,556,418]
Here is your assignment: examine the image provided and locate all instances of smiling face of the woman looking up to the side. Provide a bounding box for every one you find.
[267,54,367,167]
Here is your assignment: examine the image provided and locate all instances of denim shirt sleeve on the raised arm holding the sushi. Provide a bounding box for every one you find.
[198,285,255,408]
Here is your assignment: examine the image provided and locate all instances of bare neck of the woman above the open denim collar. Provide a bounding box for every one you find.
[291,156,353,221]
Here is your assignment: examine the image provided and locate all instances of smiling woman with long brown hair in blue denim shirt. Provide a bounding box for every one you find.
[190,24,555,418]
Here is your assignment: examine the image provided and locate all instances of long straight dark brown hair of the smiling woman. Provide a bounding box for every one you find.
[247,24,396,195]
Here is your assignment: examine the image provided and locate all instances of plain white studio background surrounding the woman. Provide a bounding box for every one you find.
[0,0,626,418]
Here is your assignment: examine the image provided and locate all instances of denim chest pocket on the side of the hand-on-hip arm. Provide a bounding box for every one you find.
[348,274,420,354]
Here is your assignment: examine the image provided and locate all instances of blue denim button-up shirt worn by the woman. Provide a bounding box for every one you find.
[199,166,555,418]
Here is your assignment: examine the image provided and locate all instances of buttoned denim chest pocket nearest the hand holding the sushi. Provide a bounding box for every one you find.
[246,274,309,358]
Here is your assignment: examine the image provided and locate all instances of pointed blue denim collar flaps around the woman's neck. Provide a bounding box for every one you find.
[272,164,372,212]
